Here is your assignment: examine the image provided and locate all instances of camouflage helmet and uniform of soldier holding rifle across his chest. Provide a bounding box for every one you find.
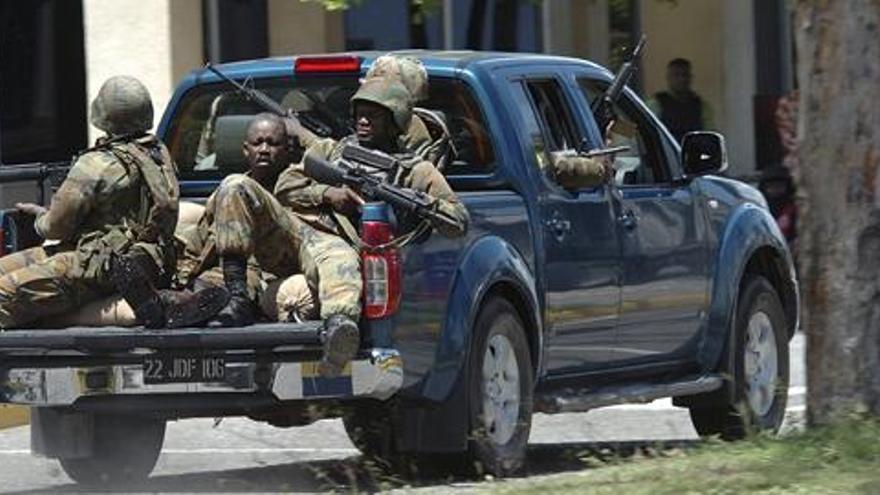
[275,78,469,317]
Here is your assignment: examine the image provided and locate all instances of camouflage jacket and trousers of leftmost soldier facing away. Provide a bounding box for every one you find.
[0,136,179,329]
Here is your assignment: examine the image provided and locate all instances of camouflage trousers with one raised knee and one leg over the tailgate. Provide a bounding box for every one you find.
[207,175,363,320]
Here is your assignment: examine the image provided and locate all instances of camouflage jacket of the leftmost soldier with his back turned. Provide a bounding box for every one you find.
[34,135,180,275]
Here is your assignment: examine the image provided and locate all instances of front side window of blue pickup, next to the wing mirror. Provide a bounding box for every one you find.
[578,79,669,186]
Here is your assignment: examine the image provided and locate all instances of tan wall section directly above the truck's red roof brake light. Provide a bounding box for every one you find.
[268,0,345,56]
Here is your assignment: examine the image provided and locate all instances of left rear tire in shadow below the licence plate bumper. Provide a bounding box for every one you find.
[59,415,165,486]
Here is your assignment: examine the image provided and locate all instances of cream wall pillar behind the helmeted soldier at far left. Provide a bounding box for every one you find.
[83,0,203,140]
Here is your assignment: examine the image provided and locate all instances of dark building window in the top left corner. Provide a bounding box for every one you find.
[0,0,87,164]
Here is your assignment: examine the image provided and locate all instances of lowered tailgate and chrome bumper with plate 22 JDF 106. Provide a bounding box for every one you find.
[0,322,403,410]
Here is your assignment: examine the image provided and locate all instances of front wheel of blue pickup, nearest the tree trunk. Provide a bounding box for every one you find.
[690,275,789,440]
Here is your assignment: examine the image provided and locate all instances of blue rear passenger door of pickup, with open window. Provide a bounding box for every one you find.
[510,76,620,375]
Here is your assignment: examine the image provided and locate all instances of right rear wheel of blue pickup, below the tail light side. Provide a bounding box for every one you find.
[467,298,534,477]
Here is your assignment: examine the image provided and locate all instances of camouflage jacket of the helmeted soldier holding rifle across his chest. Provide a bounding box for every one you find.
[275,136,470,237]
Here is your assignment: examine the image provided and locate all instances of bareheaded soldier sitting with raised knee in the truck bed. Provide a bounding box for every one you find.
[203,114,360,374]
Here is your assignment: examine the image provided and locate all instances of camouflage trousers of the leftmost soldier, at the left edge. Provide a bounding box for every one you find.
[0,247,106,330]
